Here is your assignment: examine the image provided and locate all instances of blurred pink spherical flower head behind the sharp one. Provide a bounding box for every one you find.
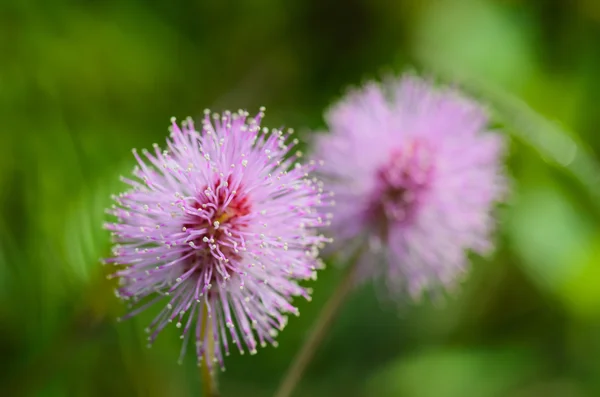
[316,75,506,297]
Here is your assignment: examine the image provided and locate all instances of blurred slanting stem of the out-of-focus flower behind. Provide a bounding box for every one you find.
[275,260,357,397]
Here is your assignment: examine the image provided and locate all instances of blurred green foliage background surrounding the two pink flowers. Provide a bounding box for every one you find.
[0,0,600,397]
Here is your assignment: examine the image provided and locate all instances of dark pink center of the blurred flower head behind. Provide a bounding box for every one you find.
[369,140,433,230]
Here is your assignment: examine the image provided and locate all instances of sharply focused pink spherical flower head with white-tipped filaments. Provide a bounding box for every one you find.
[106,108,330,368]
